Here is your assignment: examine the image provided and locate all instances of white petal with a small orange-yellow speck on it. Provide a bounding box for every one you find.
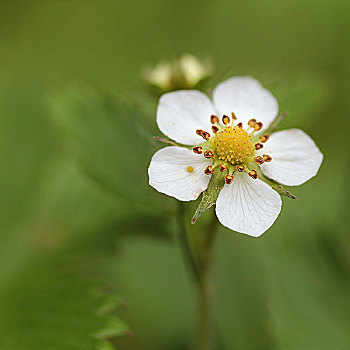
[148,146,212,201]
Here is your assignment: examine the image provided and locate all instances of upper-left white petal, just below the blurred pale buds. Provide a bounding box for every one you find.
[157,90,216,145]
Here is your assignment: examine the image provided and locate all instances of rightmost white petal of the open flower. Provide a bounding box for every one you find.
[259,129,323,186]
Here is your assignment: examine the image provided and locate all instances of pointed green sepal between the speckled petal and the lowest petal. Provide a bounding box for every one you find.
[191,169,225,224]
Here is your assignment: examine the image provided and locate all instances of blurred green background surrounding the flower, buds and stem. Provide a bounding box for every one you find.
[0,0,350,350]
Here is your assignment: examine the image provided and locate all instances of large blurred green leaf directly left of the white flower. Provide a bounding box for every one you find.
[50,88,164,211]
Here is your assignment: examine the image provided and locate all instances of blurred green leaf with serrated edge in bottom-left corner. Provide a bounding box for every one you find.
[0,255,128,350]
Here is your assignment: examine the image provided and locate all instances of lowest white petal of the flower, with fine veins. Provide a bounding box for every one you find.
[216,173,282,237]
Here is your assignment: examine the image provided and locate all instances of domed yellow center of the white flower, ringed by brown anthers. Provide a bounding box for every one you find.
[214,126,255,165]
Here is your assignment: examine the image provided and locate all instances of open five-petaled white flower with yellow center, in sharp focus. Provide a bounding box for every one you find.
[148,77,323,237]
